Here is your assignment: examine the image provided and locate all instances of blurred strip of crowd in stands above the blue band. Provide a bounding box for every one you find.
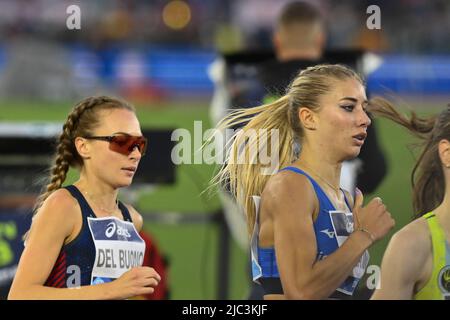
[0,0,450,53]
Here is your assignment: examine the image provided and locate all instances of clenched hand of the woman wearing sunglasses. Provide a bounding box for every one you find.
[110,267,161,299]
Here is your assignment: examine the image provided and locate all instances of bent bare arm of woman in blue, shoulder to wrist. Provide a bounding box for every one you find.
[260,172,380,299]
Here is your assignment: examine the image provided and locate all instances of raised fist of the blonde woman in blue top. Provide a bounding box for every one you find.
[353,189,395,244]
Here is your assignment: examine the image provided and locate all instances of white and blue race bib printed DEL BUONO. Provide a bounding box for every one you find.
[88,217,145,284]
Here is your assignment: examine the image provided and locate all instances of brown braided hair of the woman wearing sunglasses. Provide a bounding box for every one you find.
[24,96,135,239]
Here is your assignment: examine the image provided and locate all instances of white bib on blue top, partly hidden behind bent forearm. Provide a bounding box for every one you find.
[329,211,370,295]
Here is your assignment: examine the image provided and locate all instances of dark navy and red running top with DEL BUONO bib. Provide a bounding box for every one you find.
[45,185,145,288]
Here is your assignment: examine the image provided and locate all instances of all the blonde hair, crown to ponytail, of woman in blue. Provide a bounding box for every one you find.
[212,65,363,235]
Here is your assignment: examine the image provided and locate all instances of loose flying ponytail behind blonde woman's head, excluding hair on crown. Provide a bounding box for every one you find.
[213,96,294,232]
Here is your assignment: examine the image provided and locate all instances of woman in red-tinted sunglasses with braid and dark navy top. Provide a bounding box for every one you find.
[8,96,160,299]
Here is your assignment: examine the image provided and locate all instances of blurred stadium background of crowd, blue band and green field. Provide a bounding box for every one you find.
[0,0,450,299]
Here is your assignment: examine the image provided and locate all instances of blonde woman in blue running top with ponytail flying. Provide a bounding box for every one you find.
[214,65,394,299]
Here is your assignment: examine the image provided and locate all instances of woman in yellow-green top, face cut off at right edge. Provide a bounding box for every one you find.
[371,102,450,300]
